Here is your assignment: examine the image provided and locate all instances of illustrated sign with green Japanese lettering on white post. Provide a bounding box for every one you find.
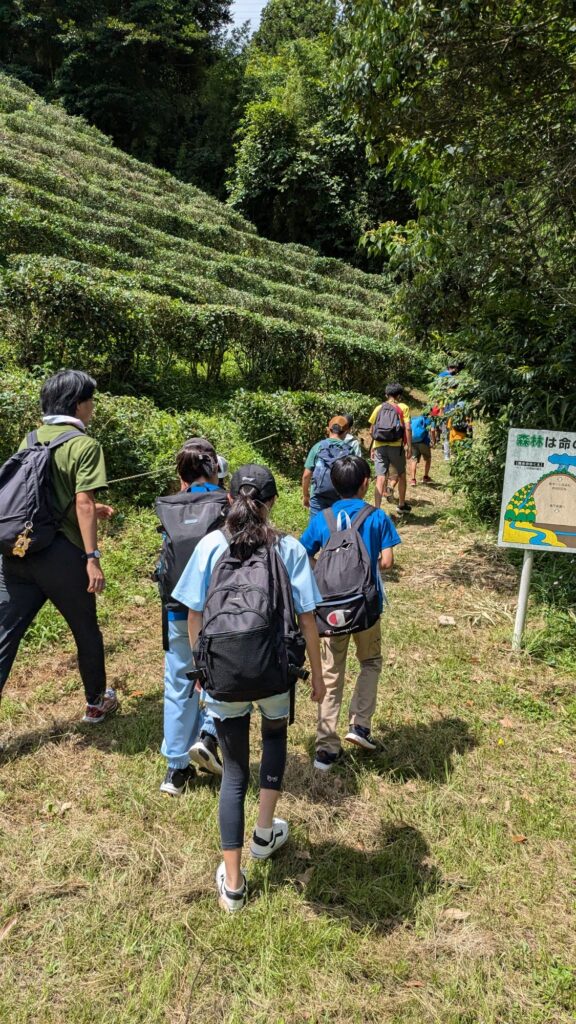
[498,428,576,651]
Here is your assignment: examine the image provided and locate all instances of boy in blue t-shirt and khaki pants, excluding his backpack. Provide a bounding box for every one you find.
[300,456,401,771]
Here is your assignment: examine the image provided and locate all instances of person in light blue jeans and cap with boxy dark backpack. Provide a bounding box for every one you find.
[156,437,230,797]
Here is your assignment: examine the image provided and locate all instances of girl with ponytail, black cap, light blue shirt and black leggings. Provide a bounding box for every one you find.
[170,465,324,911]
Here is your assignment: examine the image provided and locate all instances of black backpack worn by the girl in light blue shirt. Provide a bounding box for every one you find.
[194,547,305,700]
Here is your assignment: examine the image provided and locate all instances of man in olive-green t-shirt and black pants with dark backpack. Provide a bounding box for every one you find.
[0,370,118,725]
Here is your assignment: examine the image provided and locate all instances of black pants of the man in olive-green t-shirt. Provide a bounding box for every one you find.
[0,534,106,703]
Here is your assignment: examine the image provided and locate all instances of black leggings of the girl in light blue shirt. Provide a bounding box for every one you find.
[214,715,288,850]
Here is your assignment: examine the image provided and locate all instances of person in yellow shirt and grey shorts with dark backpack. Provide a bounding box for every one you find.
[369,384,412,512]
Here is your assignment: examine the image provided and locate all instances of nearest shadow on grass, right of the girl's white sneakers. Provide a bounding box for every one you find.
[253,823,443,935]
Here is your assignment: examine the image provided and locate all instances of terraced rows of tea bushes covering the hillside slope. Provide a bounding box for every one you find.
[0,76,420,391]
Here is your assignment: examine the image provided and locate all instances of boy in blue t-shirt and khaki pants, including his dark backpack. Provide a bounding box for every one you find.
[300,456,400,771]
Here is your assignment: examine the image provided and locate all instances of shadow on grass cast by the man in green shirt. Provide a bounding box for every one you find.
[0,693,163,765]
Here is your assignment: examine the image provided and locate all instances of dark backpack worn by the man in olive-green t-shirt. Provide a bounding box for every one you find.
[0,430,84,558]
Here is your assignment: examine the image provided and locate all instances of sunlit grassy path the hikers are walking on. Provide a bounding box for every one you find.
[0,464,576,1024]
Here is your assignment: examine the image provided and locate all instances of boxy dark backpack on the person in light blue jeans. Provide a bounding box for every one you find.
[154,490,230,611]
